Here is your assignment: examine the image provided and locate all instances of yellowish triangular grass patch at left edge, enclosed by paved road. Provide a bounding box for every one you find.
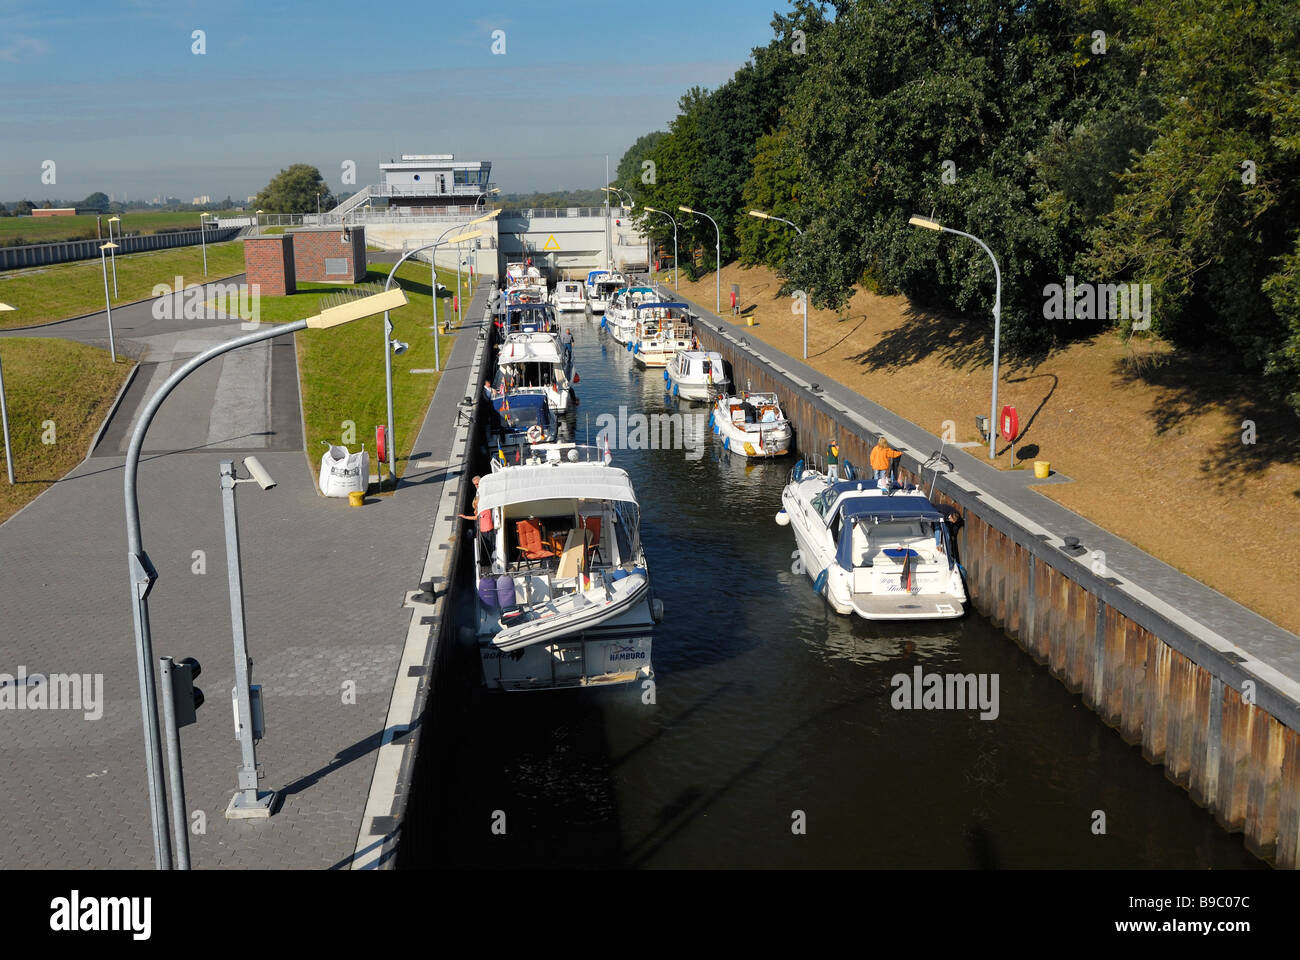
[0,337,131,520]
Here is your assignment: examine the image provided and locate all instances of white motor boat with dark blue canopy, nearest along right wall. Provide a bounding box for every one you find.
[776,460,966,620]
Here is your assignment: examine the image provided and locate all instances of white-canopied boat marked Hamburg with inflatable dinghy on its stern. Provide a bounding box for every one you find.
[475,444,663,691]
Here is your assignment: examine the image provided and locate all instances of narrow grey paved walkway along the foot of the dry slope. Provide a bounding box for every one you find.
[681,287,1300,701]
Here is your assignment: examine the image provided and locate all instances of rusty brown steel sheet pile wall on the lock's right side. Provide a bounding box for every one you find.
[697,323,1300,869]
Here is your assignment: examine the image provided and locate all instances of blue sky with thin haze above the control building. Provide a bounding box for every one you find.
[0,0,788,200]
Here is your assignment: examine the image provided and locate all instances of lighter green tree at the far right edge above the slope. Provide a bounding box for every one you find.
[1089,0,1300,410]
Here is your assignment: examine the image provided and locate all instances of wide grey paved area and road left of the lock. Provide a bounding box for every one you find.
[0,270,484,868]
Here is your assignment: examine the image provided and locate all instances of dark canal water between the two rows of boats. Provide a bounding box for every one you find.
[412,315,1261,868]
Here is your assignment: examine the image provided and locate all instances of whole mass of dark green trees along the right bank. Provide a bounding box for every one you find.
[618,0,1300,411]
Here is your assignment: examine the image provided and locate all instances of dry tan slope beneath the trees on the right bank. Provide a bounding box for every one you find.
[681,264,1300,632]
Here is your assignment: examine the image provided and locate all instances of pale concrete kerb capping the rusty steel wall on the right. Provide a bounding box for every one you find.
[696,304,1300,730]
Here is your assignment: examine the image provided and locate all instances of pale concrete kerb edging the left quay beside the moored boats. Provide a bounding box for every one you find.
[351,284,489,870]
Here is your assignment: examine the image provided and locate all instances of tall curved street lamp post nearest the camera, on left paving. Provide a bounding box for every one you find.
[122,283,406,870]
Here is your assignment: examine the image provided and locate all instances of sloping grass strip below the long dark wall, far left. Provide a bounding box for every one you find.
[0,240,244,328]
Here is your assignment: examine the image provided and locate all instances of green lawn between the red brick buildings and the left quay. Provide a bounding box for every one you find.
[233,263,456,473]
